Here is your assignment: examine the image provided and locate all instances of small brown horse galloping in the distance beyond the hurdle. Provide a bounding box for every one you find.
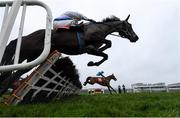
[83,74,117,94]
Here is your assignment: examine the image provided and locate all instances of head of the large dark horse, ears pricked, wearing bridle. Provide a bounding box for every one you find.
[117,15,139,42]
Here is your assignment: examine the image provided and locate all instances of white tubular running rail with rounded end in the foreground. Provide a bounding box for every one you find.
[0,0,52,72]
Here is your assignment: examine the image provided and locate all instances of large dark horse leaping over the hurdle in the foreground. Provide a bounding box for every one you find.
[0,15,138,95]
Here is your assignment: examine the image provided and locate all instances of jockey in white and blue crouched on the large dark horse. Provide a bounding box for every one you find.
[53,11,95,30]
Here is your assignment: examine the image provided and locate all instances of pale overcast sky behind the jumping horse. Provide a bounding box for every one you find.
[0,0,180,89]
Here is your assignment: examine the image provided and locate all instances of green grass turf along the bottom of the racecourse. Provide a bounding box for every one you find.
[0,93,180,117]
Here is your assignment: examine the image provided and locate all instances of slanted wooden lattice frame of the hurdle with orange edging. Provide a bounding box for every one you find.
[3,51,80,105]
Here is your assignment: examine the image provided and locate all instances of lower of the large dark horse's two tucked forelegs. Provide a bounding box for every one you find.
[86,45,108,66]
